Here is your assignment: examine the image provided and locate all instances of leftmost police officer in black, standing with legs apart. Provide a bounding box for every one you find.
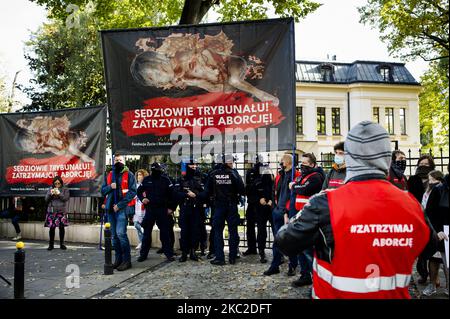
[137,162,175,262]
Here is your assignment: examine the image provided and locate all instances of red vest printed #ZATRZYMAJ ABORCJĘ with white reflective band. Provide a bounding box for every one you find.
[313,180,430,299]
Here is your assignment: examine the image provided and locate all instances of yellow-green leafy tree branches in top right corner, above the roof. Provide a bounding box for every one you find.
[358,0,449,67]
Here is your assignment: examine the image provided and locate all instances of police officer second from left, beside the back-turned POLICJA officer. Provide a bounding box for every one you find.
[175,159,204,262]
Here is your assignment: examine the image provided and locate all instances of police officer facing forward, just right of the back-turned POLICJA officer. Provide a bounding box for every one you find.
[243,155,273,263]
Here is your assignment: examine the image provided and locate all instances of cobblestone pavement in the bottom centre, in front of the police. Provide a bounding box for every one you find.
[96,251,310,299]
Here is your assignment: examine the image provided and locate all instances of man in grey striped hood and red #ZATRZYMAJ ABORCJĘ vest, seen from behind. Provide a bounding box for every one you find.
[275,121,436,299]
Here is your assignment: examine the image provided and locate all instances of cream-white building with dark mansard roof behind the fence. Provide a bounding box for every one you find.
[296,61,421,158]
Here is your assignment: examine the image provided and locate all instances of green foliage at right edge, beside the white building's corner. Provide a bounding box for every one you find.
[419,59,449,150]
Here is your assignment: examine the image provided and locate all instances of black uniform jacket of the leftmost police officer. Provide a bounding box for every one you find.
[137,175,174,209]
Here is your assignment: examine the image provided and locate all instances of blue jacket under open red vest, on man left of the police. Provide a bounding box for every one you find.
[102,166,137,212]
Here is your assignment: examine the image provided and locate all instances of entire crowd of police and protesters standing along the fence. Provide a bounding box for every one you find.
[1,122,449,298]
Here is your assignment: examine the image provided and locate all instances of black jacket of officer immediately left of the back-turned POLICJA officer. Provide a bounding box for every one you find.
[174,172,205,206]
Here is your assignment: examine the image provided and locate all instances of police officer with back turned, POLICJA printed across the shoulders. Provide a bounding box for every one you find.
[201,155,245,265]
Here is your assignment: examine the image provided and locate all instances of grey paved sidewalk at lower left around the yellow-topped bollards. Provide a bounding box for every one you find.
[0,239,165,299]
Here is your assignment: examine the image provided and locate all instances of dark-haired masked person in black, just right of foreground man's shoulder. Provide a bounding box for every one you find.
[408,154,436,284]
